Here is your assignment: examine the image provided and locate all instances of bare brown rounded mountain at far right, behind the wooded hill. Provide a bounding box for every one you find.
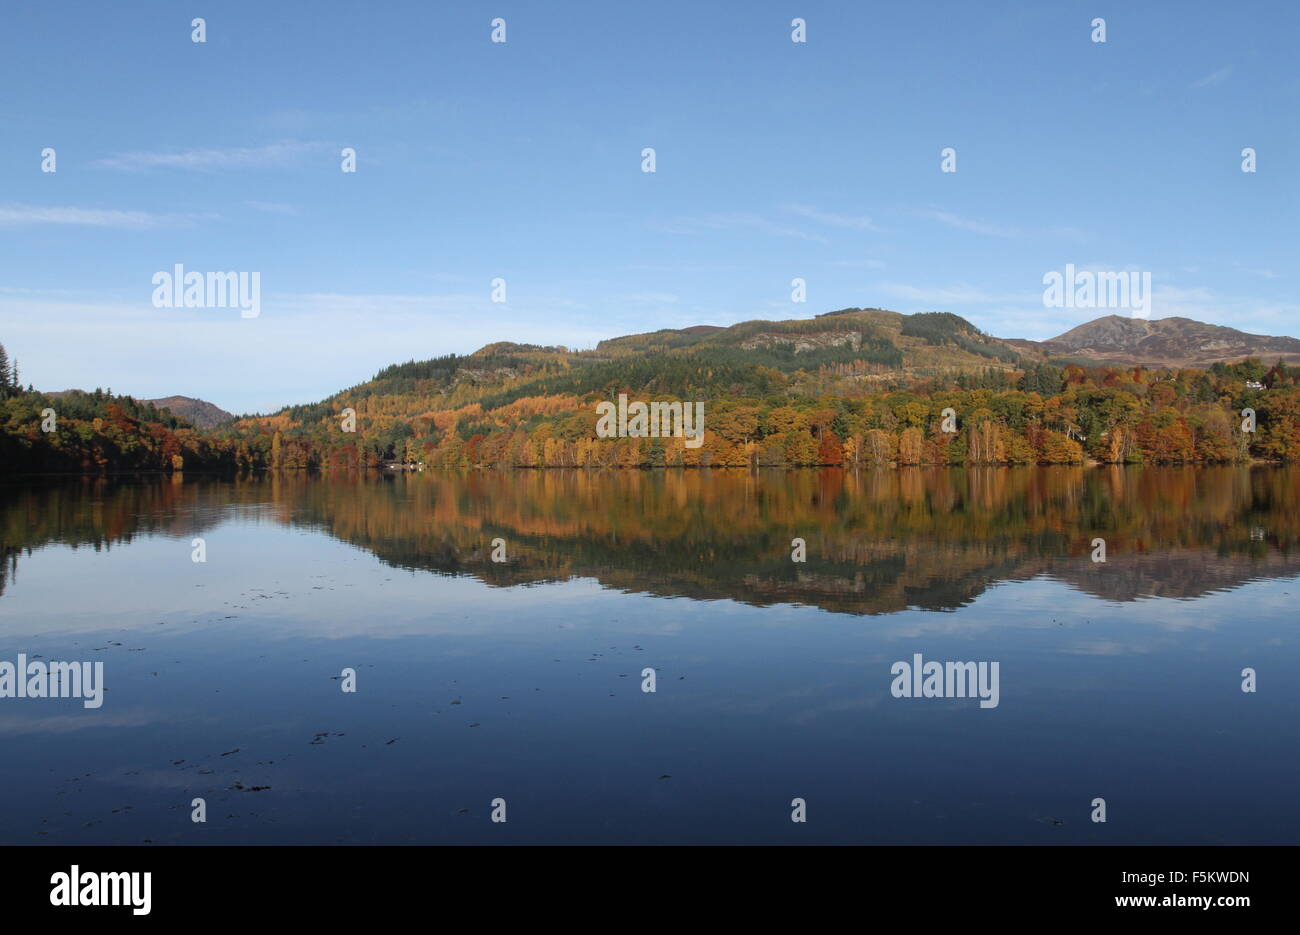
[1005,315,1300,369]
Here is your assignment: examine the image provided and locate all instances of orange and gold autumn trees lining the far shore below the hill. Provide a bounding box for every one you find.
[231,359,1300,468]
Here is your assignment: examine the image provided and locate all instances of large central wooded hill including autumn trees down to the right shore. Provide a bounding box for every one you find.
[210,308,1300,468]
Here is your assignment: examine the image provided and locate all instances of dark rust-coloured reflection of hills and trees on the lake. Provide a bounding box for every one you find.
[0,467,1300,614]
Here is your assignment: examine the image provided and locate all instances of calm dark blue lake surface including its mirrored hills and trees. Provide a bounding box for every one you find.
[0,468,1300,844]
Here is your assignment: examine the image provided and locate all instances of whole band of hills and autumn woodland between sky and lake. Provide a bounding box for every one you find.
[10,308,1300,471]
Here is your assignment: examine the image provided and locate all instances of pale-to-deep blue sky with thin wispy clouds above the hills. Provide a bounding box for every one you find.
[0,0,1300,412]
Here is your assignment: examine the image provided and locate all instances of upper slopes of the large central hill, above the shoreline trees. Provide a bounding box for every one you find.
[253,308,1013,423]
